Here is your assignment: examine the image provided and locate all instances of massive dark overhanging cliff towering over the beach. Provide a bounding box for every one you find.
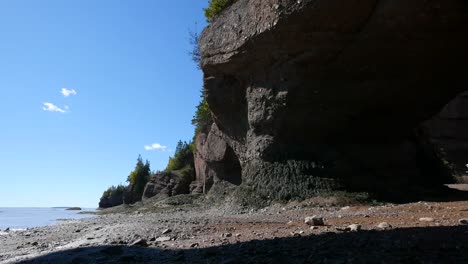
[197,0,468,199]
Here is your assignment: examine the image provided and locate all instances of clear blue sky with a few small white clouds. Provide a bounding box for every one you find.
[0,0,208,207]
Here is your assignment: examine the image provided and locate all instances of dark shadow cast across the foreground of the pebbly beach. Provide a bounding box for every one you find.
[20,226,468,263]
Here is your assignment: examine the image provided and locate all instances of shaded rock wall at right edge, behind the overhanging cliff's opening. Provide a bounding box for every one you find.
[424,92,468,179]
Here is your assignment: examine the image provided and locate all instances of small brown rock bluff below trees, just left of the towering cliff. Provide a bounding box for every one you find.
[142,167,194,201]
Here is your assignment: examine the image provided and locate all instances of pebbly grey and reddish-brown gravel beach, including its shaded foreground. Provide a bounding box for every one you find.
[0,189,468,263]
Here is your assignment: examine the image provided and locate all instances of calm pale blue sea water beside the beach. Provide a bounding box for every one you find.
[0,207,95,229]
